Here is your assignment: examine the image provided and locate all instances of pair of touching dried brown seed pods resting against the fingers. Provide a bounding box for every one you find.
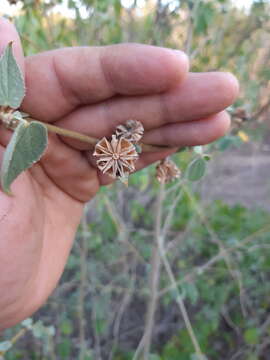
[93,120,144,183]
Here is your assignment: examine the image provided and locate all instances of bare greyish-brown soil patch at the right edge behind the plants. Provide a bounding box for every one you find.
[201,141,270,211]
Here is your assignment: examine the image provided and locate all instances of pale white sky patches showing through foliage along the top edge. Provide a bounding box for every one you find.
[0,0,258,17]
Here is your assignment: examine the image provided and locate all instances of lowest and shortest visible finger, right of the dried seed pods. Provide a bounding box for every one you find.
[143,111,230,147]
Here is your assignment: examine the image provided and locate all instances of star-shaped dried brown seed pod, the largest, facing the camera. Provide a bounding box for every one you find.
[93,135,139,179]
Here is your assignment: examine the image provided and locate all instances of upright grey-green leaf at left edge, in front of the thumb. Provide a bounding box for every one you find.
[0,43,25,109]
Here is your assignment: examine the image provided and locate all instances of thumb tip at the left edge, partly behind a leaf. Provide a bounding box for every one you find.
[0,17,24,73]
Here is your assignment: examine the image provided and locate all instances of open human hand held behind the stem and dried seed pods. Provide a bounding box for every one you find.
[0,19,238,330]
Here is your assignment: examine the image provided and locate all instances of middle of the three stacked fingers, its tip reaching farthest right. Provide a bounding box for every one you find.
[56,72,238,150]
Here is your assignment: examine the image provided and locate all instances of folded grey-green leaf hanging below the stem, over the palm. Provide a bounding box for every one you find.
[1,121,48,195]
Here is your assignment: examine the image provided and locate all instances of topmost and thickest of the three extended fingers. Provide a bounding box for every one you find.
[23,44,188,121]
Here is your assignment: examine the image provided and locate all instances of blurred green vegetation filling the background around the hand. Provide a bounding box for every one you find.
[0,0,270,360]
